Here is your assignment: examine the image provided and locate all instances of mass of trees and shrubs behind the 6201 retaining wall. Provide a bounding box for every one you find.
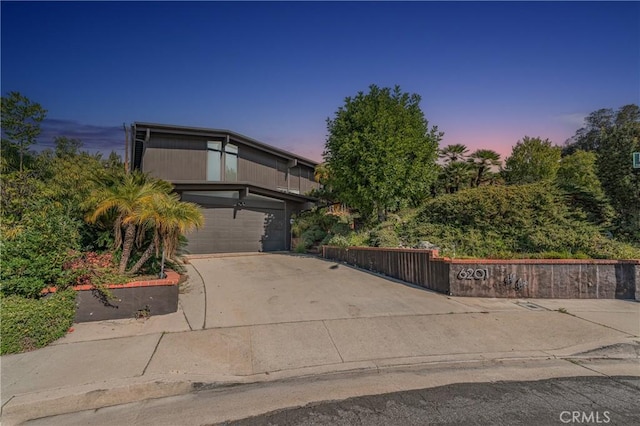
[292,95,640,259]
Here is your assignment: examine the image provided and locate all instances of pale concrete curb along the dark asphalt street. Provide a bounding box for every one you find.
[2,345,638,425]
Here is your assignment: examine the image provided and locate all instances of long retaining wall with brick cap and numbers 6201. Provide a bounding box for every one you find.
[322,246,640,300]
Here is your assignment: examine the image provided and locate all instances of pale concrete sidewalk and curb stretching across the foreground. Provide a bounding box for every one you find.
[1,265,640,425]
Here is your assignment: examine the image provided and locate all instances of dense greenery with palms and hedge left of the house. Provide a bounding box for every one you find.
[0,92,203,354]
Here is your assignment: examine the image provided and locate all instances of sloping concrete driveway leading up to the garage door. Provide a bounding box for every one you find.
[190,254,480,328]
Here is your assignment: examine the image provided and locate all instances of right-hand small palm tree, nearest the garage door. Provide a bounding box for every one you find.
[130,193,204,278]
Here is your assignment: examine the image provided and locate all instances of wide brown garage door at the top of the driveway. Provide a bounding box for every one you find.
[187,206,286,254]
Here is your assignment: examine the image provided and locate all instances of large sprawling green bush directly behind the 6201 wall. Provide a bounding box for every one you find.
[397,184,640,258]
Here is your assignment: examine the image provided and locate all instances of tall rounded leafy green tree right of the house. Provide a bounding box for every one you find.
[324,85,443,222]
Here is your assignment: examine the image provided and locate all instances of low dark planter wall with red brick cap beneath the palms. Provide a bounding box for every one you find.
[45,271,180,323]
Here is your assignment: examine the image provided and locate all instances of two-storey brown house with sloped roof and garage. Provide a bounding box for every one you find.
[130,122,319,254]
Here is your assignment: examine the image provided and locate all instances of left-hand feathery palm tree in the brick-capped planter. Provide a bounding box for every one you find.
[86,172,171,274]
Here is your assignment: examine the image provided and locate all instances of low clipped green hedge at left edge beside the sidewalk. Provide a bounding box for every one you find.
[0,290,76,355]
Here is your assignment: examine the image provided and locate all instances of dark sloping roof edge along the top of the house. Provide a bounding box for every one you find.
[133,121,320,168]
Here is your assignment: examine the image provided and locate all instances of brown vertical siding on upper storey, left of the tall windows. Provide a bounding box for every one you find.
[142,135,207,181]
